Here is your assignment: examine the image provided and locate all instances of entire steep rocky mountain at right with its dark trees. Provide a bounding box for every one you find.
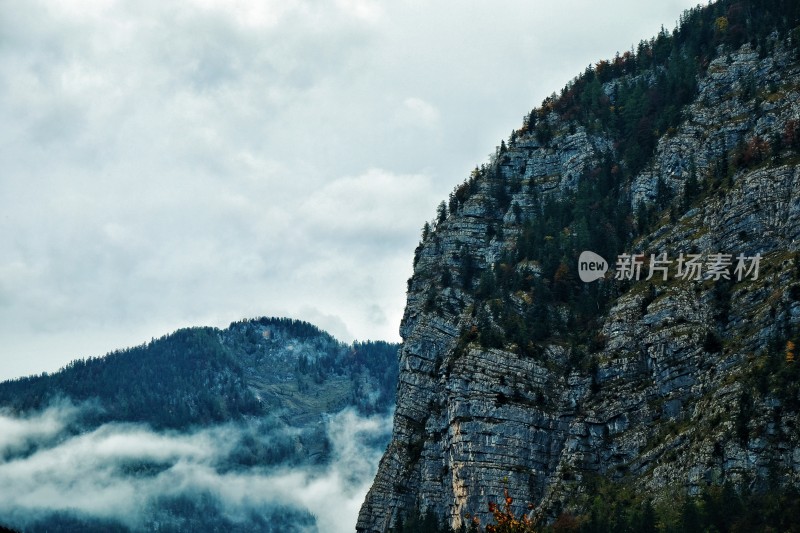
[357,0,800,532]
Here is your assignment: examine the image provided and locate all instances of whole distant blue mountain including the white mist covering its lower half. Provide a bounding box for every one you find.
[0,318,398,533]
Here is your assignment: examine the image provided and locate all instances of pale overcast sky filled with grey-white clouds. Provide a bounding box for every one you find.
[0,0,696,379]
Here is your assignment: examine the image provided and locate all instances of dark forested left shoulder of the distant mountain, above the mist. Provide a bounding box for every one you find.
[0,328,262,428]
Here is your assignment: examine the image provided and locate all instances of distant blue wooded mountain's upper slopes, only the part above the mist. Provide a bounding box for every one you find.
[0,318,397,428]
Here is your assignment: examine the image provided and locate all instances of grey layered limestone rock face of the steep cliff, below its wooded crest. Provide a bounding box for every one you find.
[357,6,800,532]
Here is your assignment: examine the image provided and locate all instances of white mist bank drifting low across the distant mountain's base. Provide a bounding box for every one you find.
[0,404,391,532]
